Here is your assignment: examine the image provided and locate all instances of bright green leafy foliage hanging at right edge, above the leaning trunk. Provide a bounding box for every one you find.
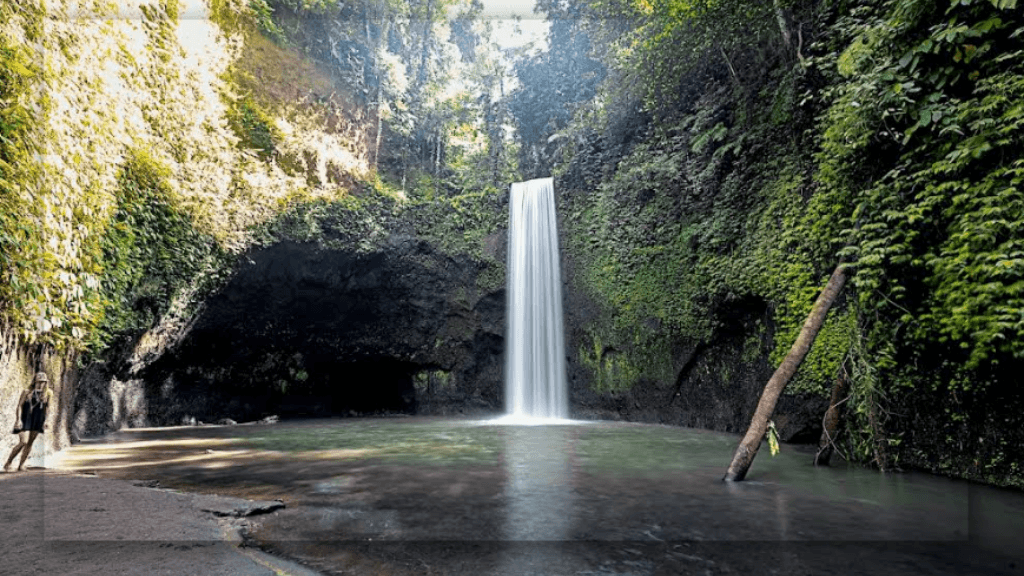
[819,1,1024,367]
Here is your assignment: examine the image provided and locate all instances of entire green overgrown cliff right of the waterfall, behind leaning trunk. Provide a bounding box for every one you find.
[555,0,1024,487]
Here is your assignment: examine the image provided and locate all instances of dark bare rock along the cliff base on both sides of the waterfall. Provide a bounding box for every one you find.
[64,186,824,441]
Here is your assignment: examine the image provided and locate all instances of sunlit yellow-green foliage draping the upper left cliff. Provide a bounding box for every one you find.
[0,0,366,359]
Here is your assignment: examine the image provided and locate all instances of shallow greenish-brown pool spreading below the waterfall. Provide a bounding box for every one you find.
[54,418,1024,574]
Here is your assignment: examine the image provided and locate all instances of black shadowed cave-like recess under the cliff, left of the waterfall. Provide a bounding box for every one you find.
[141,242,504,424]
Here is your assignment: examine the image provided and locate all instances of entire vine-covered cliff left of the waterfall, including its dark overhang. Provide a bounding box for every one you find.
[0,0,504,449]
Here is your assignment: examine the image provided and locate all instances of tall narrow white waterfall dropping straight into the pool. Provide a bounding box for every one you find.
[505,178,568,418]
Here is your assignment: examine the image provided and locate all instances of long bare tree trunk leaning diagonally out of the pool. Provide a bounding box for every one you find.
[724,262,847,482]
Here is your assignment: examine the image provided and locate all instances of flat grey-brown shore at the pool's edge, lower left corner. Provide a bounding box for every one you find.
[0,467,317,576]
